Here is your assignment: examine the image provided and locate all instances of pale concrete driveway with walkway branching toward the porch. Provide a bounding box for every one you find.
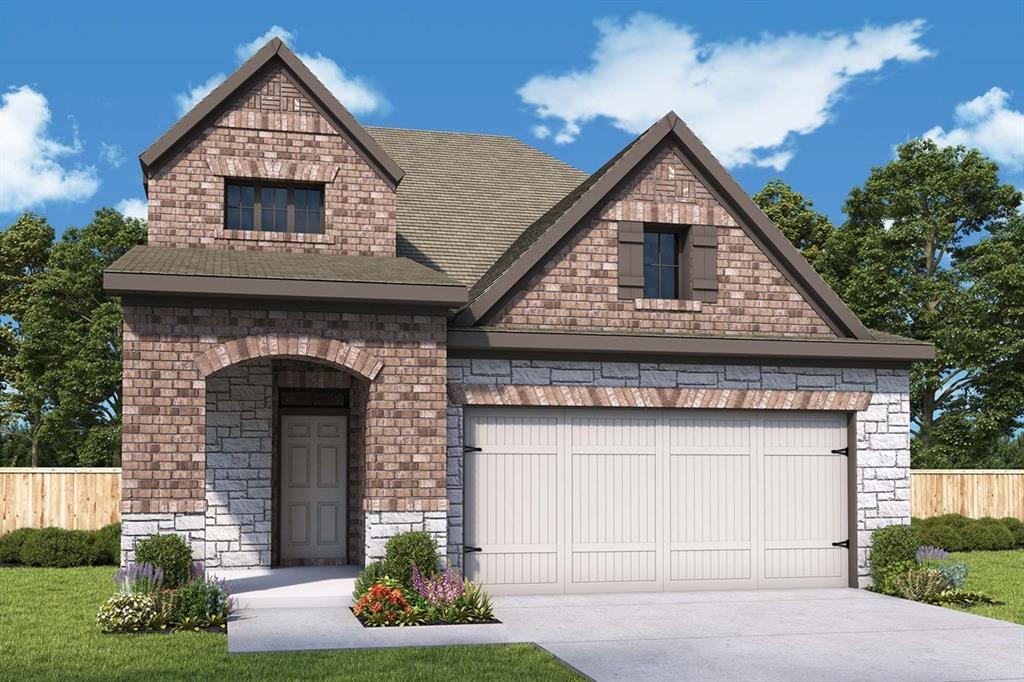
[228,589,1024,682]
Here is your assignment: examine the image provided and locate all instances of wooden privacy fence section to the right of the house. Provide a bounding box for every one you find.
[910,469,1024,521]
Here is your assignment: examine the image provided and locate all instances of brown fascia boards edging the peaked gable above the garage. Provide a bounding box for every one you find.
[453,112,873,340]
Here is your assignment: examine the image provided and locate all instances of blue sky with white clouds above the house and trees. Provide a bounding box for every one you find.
[0,0,1024,229]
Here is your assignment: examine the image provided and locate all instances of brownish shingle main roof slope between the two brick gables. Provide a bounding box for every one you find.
[367,127,587,287]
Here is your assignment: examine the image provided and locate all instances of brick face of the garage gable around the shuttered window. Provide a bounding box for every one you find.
[486,146,836,338]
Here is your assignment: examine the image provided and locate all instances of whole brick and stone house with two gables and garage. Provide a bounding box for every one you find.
[104,40,933,592]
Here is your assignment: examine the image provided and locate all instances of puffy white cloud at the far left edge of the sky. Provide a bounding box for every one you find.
[0,85,99,212]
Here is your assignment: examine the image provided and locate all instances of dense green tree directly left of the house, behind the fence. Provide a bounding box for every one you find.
[0,209,145,466]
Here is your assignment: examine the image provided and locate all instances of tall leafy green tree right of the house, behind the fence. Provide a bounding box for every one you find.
[816,140,1024,466]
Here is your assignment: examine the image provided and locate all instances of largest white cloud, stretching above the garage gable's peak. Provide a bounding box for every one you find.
[519,13,933,170]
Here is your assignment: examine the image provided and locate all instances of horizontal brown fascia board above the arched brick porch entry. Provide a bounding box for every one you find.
[103,272,468,308]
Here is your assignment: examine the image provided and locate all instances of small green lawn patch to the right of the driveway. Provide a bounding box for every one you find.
[950,550,1024,625]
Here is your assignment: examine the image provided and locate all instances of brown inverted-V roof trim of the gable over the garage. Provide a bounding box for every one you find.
[455,113,872,339]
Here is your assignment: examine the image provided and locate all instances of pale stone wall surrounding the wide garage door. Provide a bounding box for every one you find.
[446,358,910,586]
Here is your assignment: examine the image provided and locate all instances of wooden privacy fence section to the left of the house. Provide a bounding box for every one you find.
[0,467,121,534]
